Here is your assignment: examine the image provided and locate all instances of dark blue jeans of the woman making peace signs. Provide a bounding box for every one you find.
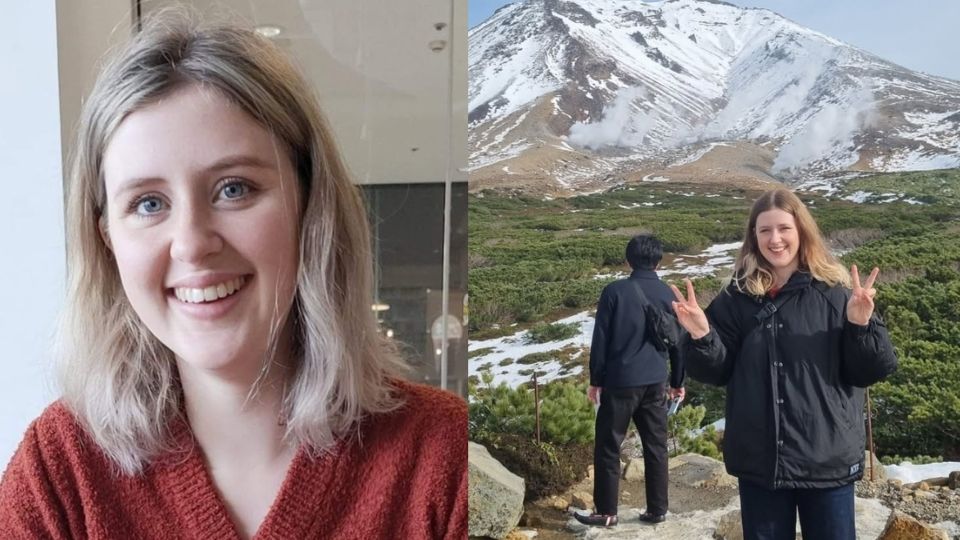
[740,480,857,540]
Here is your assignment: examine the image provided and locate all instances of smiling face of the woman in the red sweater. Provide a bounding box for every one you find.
[101,85,299,378]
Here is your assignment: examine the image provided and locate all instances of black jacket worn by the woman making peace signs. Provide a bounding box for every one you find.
[684,272,897,489]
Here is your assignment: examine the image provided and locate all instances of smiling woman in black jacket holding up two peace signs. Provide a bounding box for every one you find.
[673,189,897,540]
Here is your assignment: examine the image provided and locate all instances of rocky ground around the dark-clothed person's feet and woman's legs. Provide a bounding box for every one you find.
[508,454,960,540]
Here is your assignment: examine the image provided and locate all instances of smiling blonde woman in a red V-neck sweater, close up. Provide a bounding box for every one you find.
[0,13,467,539]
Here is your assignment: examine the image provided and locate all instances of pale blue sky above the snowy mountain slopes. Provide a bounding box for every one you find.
[467,0,960,81]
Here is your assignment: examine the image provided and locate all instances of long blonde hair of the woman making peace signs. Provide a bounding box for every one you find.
[733,188,850,296]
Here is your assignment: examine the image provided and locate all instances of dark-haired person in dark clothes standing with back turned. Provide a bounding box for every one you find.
[575,235,684,526]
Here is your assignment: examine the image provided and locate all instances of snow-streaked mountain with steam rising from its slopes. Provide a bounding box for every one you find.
[468,0,960,191]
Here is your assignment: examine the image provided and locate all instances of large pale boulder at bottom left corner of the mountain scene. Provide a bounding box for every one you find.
[468,442,524,538]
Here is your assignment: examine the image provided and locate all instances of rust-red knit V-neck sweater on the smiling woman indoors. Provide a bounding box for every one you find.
[0,383,467,540]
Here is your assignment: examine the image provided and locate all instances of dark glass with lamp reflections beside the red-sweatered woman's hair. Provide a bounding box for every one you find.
[363,182,467,395]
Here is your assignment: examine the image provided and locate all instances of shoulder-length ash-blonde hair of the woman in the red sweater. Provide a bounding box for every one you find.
[58,11,407,474]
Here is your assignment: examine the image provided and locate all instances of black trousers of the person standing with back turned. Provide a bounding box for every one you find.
[593,383,667,514]
